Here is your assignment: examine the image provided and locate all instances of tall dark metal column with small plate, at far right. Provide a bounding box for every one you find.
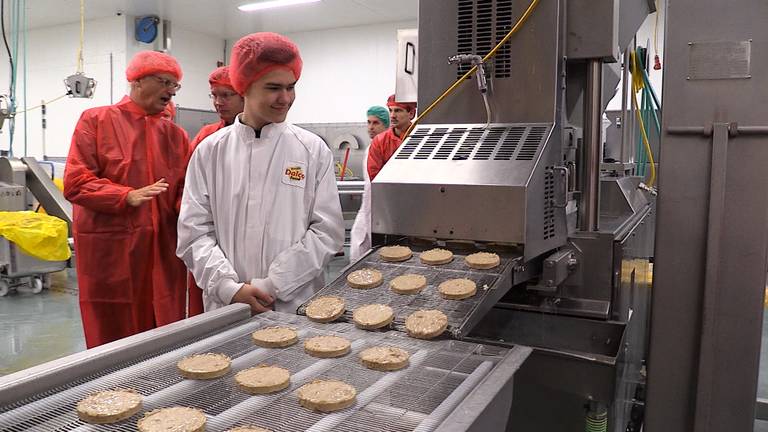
[646,0,768,432]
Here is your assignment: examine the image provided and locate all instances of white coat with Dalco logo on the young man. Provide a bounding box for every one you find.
[176,116,344,313]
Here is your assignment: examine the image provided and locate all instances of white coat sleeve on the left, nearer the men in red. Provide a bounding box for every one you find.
[176,148,243,305]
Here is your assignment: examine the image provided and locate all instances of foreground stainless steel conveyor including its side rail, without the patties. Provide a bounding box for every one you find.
[0,305,530,432]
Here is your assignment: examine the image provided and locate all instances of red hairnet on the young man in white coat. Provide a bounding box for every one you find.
[229,32,302,94]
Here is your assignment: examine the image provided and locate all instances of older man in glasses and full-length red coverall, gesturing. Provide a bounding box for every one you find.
[64,51,194,348]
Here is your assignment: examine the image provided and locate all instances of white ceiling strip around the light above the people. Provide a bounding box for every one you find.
[26,0,418,39]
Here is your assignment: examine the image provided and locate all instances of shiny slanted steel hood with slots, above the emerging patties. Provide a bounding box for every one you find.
[371,123,566,259]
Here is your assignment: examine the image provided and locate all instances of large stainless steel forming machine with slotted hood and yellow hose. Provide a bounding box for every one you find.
[366,0,654,431]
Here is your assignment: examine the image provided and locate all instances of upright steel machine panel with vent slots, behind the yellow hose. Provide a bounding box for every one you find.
[418,0,562,123]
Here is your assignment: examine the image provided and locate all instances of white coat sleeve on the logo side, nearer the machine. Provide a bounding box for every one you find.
[255,144,344,301]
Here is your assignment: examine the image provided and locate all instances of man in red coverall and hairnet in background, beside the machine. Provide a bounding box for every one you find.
[368,95,416,181]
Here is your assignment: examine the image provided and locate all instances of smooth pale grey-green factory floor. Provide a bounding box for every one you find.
[0,257,768,432]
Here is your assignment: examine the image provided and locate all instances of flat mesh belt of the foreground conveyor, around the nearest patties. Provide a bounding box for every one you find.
[0,312,527,432]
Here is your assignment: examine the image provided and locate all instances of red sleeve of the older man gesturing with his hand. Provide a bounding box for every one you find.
[64,111,133,214]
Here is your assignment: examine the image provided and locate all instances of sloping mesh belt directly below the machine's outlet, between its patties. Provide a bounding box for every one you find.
[298,248,520,338]
